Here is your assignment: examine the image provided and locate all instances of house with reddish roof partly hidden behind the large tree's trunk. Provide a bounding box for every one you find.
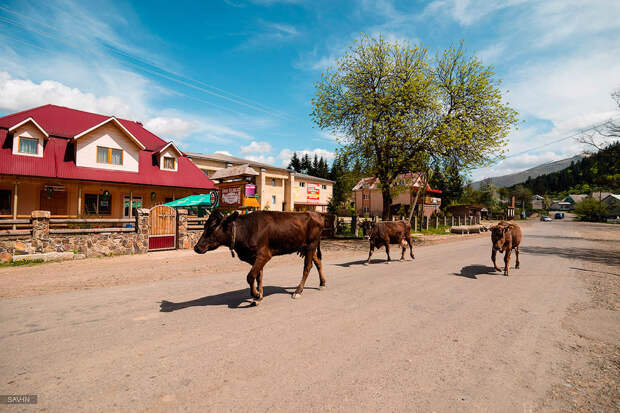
[352,172,441,217]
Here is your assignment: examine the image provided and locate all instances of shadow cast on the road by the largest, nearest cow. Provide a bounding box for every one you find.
[159,286,302,313]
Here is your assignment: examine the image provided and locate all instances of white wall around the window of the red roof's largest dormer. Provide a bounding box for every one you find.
[75,123,140,172]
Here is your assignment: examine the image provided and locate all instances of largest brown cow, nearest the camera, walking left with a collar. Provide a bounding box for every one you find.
[194,211,325,305]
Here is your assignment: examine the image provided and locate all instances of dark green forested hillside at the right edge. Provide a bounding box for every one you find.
[522,141,620,195]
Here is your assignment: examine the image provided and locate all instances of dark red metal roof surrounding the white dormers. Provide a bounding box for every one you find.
[0,105,215,189]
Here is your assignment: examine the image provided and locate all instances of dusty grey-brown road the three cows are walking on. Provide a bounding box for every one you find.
[0,222,620,412]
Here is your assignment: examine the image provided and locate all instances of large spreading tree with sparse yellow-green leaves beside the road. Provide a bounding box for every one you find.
[312,36,517,219]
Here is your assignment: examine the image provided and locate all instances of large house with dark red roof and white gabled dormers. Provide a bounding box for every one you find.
[0,105,216,218]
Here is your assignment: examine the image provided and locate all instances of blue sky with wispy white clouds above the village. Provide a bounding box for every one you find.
[0,0,620,179]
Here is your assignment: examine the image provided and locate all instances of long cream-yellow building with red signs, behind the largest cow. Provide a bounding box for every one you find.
[187,152,334,212]
